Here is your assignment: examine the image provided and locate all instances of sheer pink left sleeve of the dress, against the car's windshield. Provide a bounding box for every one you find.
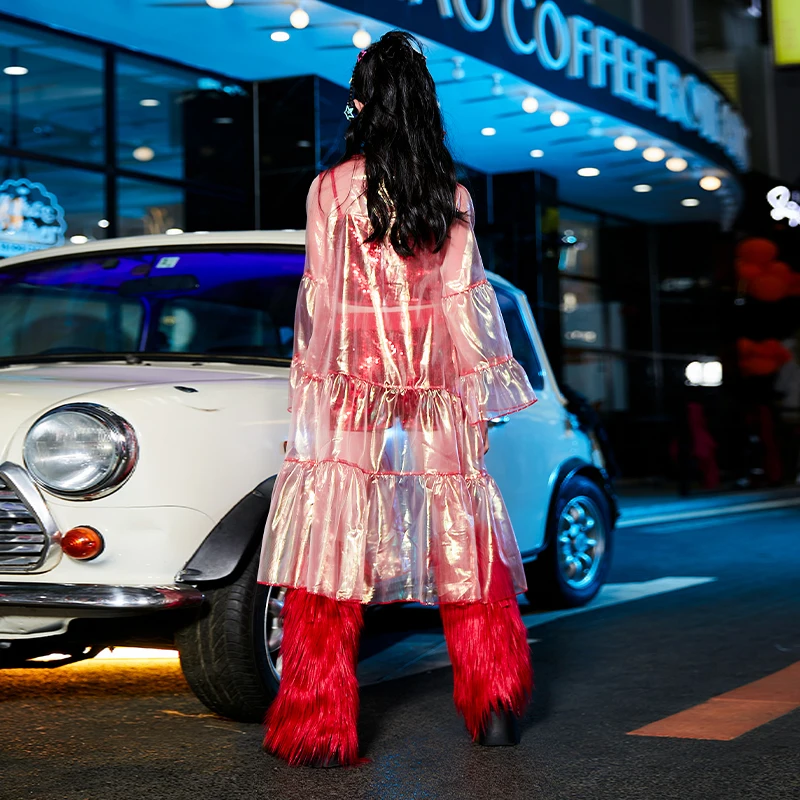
[288,175,329,411]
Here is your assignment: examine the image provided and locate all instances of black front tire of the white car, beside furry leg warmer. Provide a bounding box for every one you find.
[175,550,285,722]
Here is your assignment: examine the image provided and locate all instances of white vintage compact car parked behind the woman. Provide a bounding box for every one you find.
[0,231,616,720]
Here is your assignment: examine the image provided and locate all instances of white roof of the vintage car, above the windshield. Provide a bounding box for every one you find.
[0,229,522,294]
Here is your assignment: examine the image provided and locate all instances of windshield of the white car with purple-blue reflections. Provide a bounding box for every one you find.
[0,248,304,362]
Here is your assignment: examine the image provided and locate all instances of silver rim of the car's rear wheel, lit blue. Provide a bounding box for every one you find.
[558,496,606,589]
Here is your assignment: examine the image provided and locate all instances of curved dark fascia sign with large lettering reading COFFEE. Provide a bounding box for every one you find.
[333,0,749,171]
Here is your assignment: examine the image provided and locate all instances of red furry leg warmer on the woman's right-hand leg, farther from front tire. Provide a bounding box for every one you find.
[440,597,533,739]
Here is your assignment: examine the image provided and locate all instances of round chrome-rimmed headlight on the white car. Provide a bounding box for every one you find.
[24,403,139,500]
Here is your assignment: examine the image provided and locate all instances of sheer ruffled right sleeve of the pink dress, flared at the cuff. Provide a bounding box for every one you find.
[442,186,536,424]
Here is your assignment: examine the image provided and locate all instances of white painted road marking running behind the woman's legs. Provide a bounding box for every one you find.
[358,578,716,686]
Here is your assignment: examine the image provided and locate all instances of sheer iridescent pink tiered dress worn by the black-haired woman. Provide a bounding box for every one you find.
[258,158,536,603]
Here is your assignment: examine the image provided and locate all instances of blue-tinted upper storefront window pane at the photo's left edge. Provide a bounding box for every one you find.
[0,21,105,163]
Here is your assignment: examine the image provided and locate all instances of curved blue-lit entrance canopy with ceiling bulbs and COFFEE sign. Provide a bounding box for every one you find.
[0,0,748,223]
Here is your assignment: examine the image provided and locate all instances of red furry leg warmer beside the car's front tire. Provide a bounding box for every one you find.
[264,589,363,766]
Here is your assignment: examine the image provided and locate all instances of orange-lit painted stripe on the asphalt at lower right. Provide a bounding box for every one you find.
[628,661,800,742]
